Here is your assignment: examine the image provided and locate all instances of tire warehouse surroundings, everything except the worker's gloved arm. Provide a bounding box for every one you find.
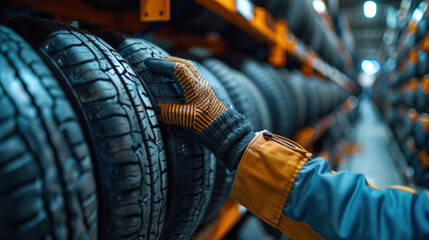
[0,0,429,239]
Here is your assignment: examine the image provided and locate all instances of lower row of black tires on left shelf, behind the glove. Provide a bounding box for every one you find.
[0,17,347,239]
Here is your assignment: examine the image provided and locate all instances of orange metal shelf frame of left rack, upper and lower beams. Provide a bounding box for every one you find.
[0,0,358,239]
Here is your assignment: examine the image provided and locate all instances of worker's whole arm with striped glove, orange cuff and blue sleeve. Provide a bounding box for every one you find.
[145,58,429,240]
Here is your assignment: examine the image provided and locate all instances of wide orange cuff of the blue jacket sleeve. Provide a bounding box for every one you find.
[231,131,311,227]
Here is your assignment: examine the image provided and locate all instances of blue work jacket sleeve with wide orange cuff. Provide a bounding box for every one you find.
[231,131,429,239]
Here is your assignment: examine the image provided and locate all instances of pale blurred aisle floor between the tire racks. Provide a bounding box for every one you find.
[338,98,405,188]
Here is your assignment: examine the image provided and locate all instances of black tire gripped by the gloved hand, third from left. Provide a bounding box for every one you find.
[96,31,216,239]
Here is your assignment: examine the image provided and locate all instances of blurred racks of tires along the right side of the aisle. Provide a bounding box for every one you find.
[372,7,429,187]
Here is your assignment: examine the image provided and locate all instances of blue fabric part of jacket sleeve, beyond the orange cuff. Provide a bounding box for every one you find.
[283,158,429,240]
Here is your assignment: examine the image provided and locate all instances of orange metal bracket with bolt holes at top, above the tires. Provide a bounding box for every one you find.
[140,0,170,22]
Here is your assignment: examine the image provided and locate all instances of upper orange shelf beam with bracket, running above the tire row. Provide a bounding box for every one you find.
[8,0,358,92]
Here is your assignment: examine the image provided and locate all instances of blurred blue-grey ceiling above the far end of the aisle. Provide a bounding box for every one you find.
[339,0,401,62]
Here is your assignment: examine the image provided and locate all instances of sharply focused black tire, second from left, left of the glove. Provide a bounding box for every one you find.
[6,17,167,239]
